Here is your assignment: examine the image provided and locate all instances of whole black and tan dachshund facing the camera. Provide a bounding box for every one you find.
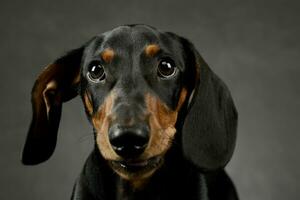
[22,24,238,200]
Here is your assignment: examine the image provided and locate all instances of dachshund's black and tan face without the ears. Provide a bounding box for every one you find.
[81,26,193,178]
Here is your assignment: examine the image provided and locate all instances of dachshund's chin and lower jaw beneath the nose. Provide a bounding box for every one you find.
[109,156,163,180]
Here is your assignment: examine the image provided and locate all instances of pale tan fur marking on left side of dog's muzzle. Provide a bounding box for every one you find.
[92,91,118,160]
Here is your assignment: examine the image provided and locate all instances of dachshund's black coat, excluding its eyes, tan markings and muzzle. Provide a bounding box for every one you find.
[22,25,238,200]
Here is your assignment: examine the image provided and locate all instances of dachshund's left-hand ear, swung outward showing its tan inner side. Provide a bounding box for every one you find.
[22,47,84,165]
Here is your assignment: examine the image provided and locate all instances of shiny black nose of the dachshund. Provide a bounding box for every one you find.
[109,125,149,158]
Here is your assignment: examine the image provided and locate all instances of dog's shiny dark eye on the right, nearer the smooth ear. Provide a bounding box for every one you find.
[157,59,176,78]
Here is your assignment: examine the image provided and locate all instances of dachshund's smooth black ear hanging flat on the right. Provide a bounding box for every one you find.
[182,41,237,171]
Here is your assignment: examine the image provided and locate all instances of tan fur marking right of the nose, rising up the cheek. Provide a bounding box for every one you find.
[145,88,187,157]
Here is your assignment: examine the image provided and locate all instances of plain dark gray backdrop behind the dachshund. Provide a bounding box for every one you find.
[0,0,300,200]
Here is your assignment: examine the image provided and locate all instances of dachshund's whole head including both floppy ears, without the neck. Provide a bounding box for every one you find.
[22,25,237,179]
